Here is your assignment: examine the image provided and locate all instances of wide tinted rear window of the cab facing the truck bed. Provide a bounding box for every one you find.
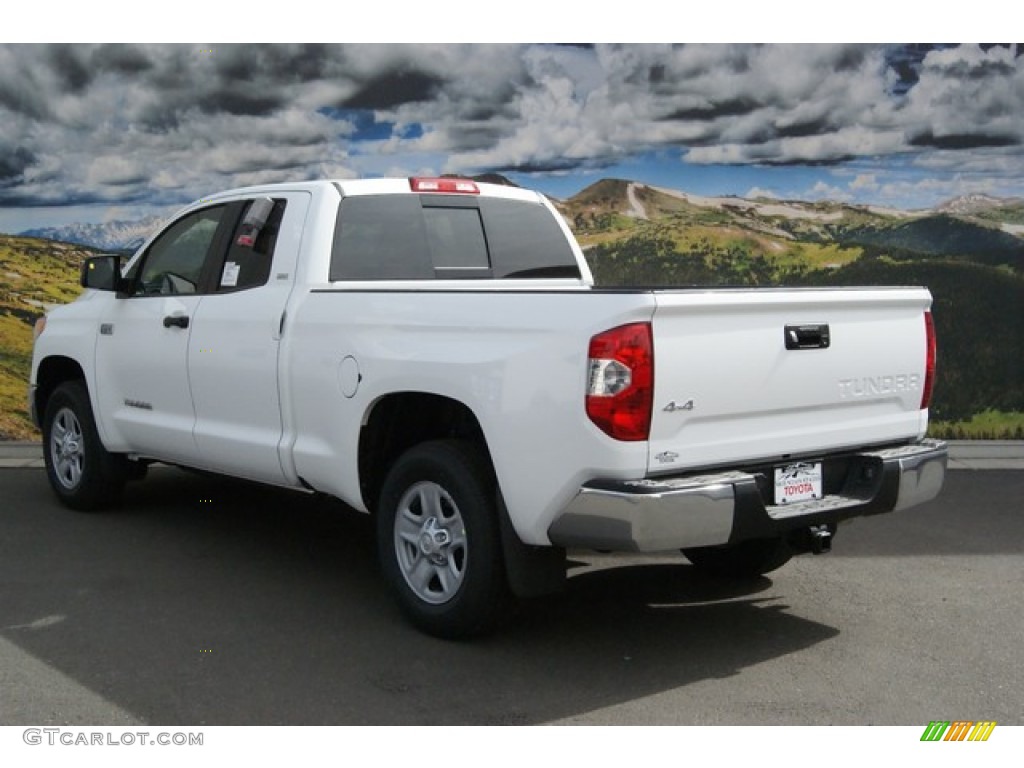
[330,195,581,281]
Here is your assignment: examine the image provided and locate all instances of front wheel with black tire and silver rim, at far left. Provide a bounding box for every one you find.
[43,381,126,511]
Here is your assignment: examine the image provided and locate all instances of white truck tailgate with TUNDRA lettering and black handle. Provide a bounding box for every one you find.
[648,288,932,474]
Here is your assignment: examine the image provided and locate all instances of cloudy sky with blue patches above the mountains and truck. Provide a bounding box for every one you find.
[0,44,1024,232]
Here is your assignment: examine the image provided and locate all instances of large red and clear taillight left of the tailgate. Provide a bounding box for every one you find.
[587,323,654,440]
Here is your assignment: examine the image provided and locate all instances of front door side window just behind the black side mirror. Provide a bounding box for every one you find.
[134,206,226,296]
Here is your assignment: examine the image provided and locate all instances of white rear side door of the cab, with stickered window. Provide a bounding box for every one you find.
[187,193,310,482]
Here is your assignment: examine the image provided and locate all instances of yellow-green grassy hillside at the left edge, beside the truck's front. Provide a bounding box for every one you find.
[0,234,91,439]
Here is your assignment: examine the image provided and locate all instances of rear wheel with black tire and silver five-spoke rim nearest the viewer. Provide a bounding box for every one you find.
[377,440,509,639]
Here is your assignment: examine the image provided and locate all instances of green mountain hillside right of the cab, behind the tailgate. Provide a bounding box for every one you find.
[577,177,1024,438]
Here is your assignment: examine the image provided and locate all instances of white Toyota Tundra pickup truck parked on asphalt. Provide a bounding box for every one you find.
[30,178,946,637]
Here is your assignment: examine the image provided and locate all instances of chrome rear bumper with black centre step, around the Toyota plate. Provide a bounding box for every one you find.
[548,440,947,552]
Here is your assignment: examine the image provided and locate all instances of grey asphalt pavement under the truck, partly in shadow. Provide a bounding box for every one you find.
[0,445,1024,728]
